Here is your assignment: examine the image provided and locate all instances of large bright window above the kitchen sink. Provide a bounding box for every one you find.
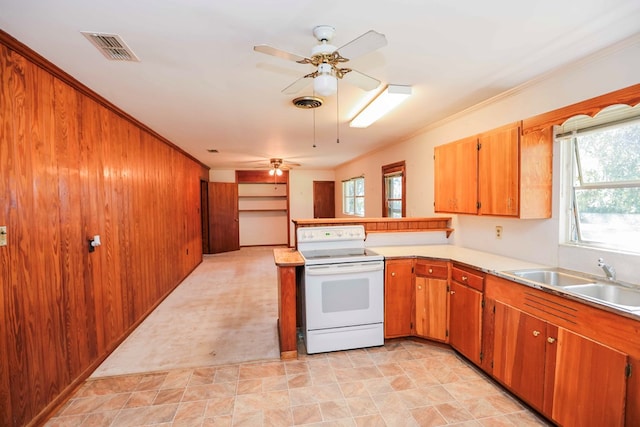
[560,108,640,253]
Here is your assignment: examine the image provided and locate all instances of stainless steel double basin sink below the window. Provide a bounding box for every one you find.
[505,268,640,311]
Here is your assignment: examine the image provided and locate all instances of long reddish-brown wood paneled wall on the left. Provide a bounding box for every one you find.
[0,31,208,426]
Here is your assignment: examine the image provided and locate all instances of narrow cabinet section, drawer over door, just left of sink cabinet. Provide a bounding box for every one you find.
[449,264,484,365]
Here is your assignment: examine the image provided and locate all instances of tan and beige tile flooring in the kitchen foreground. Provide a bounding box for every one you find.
[47,340,549,427]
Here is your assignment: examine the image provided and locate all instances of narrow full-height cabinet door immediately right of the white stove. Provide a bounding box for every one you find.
[384,259,413,338]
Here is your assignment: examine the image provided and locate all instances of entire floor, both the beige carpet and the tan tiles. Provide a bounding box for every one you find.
[47,248,547,427]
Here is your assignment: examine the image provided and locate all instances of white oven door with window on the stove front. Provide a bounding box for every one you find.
[304,261,384,331]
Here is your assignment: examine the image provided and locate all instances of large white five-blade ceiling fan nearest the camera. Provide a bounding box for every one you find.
[253,25,387,96]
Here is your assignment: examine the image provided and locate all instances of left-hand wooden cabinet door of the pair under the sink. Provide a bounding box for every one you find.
[493,301,547,411]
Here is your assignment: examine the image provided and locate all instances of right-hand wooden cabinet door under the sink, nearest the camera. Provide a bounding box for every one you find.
[547,328,633,427]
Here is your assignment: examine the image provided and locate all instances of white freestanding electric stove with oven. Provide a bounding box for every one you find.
[297,225,384,353]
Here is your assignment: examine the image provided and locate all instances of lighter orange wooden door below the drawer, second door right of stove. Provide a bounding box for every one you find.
[415,276,449,342]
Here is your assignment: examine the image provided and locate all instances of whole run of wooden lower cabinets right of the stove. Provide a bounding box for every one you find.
[385,258,640,427]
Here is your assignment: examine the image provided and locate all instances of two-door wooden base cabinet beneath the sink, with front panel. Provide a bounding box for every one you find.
[487,277,629,427]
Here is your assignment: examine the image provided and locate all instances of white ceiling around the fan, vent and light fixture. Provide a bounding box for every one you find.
[0,0,640,169]
